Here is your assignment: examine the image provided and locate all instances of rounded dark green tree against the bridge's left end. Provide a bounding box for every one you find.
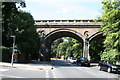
[16,12,39,60]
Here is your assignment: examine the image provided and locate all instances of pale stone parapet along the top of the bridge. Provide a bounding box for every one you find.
[35,20,102,25]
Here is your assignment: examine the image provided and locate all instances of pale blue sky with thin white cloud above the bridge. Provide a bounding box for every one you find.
[20,0,102,20]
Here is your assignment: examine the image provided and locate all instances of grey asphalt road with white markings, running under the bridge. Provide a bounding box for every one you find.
[0,60,118,78]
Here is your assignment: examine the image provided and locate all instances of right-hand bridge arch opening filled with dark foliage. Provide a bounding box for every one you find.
[88,31,105,61]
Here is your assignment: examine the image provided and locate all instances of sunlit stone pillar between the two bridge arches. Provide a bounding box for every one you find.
[83,39,90,60]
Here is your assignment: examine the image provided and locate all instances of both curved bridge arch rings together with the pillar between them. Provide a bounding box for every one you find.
[40,28,103,60]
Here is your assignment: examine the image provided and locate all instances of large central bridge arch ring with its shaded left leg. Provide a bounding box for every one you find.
[44,29,83,59]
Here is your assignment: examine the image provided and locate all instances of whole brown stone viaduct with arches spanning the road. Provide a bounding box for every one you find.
[35,20,102,60]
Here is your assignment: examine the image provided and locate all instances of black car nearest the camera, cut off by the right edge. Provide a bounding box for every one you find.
[98,60,120,73]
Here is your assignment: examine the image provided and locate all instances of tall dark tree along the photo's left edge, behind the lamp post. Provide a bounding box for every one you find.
[2,2,18,47]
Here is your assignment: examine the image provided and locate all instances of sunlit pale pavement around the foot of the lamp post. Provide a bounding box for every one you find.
[0,61,53,70]
